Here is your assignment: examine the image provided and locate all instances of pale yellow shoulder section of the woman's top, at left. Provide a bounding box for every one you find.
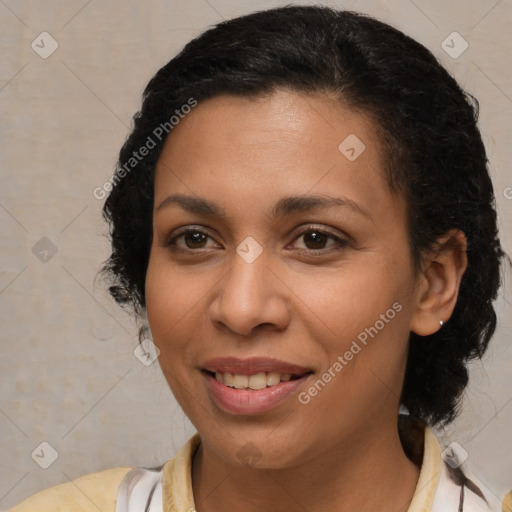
[10,467,132,512]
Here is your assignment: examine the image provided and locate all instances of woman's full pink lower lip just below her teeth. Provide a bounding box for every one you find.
[201,371,311,414]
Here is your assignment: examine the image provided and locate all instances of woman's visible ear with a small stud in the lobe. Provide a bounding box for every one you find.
[411,229,468,336]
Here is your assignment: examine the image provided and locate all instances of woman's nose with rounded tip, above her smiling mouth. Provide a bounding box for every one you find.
[209,251,290,336]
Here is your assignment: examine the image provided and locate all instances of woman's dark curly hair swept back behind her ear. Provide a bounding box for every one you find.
[99,6,504,425]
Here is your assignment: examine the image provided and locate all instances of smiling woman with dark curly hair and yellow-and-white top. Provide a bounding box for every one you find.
[13,7,503,512]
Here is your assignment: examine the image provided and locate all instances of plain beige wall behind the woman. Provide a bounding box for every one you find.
[0,0,512,509]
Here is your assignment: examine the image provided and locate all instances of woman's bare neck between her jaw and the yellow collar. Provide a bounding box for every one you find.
[192,422,419,512]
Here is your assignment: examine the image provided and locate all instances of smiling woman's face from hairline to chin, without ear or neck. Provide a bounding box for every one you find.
[146,90,417,468]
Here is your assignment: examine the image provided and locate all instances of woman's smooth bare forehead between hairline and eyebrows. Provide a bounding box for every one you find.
[155,90,401,224]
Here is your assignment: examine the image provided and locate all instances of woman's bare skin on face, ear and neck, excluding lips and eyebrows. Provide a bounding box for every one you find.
[146,90,466,512]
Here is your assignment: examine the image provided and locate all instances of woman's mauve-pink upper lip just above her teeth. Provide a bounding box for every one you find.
[203,357,312,375]
